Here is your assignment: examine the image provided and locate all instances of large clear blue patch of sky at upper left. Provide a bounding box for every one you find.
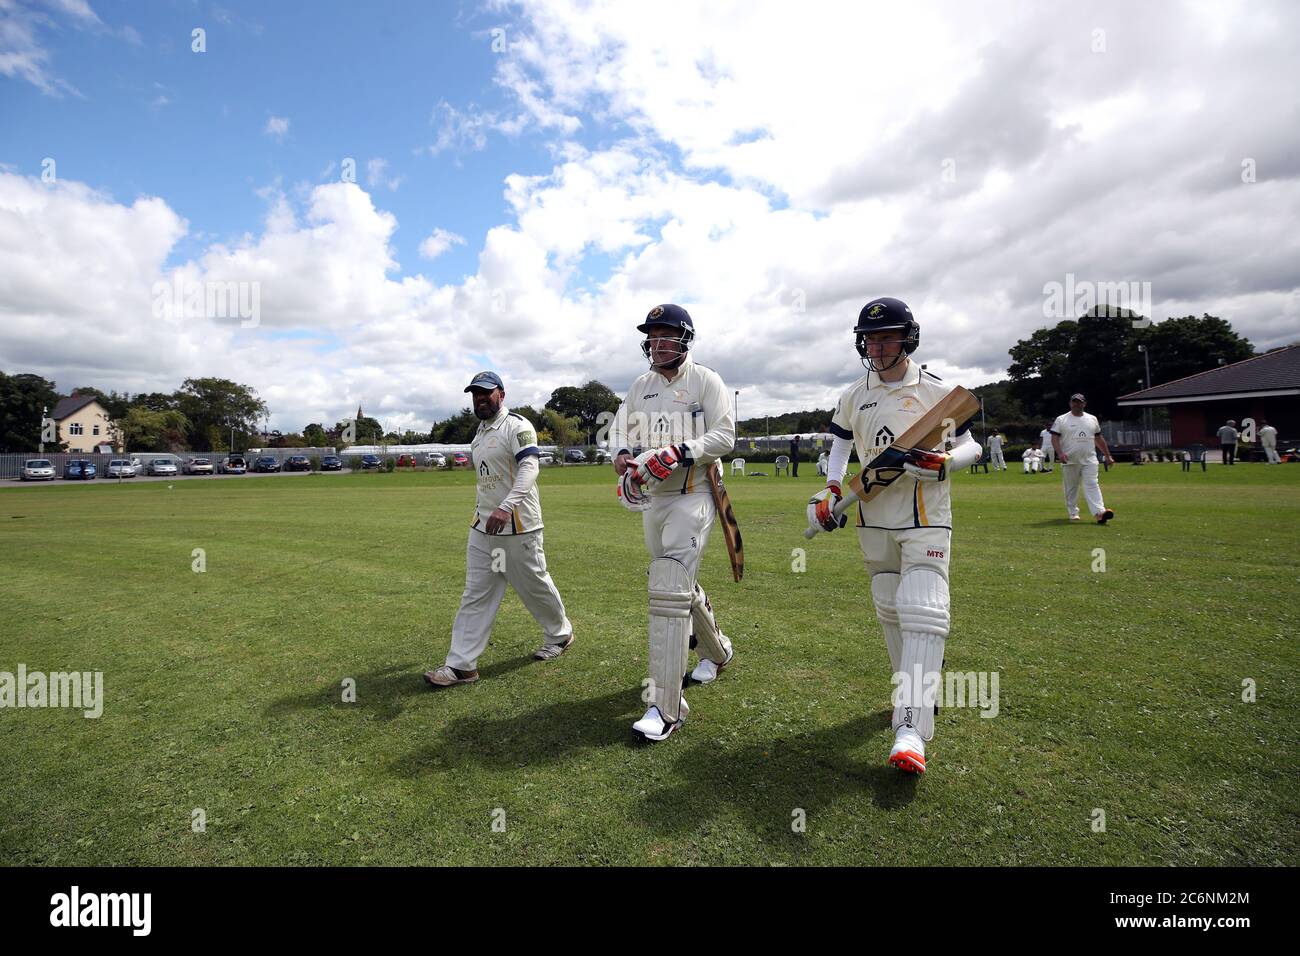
[0,1,564,281]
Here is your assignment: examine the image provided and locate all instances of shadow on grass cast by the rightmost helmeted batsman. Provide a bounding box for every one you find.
[641,711,917,835]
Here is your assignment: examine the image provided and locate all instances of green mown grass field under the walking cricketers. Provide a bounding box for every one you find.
[0,464,1300,865]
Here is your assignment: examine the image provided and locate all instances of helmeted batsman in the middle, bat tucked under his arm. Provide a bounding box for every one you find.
[610,304,736,740]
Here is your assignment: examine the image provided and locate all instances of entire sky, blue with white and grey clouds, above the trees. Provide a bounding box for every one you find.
[0,0,1300,431]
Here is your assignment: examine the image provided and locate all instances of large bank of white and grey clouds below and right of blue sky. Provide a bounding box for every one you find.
[0,0,1300,428]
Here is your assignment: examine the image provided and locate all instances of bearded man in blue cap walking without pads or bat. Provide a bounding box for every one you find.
[424,372,573,687]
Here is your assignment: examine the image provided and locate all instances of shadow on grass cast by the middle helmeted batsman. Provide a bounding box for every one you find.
[391,688,644,777]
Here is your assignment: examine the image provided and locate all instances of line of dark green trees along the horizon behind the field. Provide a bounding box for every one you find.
[0,308,1255,453]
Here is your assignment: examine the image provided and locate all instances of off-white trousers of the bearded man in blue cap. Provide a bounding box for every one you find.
[447,528,573,671]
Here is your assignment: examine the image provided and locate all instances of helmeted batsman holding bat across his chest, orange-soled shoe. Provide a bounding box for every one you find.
[807,298,982,774]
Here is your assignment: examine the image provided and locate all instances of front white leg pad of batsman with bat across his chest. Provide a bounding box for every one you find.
[893,567,949,740]
